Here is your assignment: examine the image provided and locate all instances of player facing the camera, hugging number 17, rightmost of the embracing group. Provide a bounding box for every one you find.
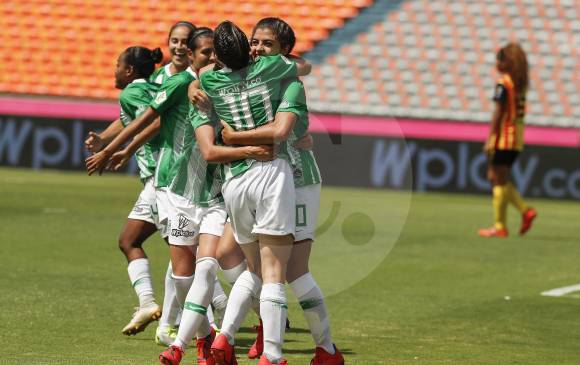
[222,18,344,365]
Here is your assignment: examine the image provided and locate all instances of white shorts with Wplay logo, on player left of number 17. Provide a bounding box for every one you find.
[156,188,227,246]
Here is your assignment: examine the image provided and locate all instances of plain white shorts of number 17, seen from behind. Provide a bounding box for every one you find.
[222,159,296,244]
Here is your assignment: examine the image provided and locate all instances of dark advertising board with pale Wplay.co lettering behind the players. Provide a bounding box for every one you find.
[0,116,580,199]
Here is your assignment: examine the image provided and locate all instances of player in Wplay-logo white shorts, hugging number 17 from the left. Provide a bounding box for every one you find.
[88,28,272,364]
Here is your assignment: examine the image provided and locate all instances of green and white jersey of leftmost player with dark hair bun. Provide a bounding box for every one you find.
[119,79,159,180]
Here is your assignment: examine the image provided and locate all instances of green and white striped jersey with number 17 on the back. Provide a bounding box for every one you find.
[200,55,297,179]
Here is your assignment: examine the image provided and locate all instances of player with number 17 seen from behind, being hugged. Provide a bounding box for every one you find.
[188,21,310,365]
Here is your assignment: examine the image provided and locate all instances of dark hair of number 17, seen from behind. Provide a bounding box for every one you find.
[213,20,250,70]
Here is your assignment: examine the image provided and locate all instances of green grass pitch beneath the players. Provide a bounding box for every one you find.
[0,169,580,365]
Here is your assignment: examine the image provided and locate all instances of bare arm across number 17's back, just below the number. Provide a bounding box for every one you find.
[221,112,298,146]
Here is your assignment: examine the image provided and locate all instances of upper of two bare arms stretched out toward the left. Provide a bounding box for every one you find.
[85,107,159,175]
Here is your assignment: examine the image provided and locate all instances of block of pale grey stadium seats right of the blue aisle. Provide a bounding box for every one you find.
[304,0,580,127]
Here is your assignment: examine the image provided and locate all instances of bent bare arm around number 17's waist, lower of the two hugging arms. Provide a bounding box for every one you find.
[195,124,275,163]
